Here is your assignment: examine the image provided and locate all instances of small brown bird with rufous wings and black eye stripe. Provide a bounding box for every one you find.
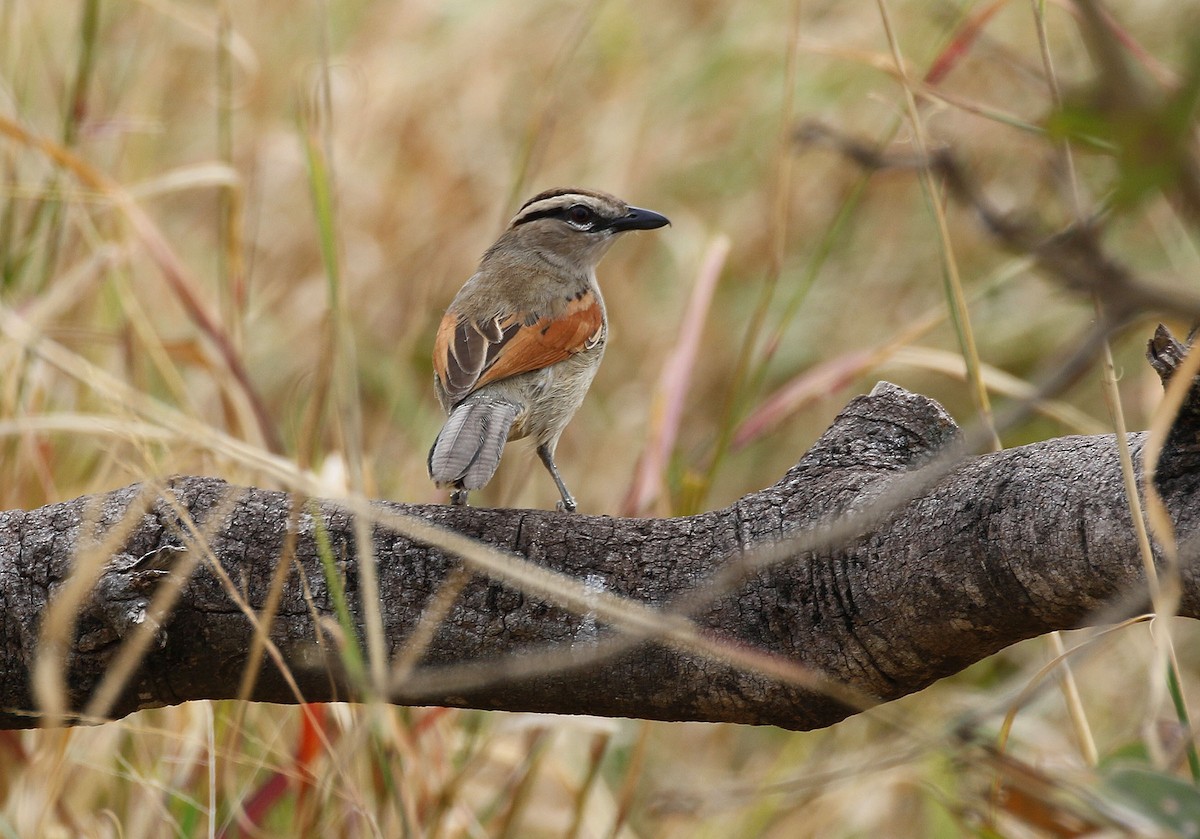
[428,187,671,513]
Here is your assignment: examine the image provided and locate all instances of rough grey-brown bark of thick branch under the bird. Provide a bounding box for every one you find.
[0,334,1200,729]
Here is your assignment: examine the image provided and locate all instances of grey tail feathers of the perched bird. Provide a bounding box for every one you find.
[428,396,520,490]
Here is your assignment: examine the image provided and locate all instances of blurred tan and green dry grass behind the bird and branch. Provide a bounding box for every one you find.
[0,0,1200,837]
